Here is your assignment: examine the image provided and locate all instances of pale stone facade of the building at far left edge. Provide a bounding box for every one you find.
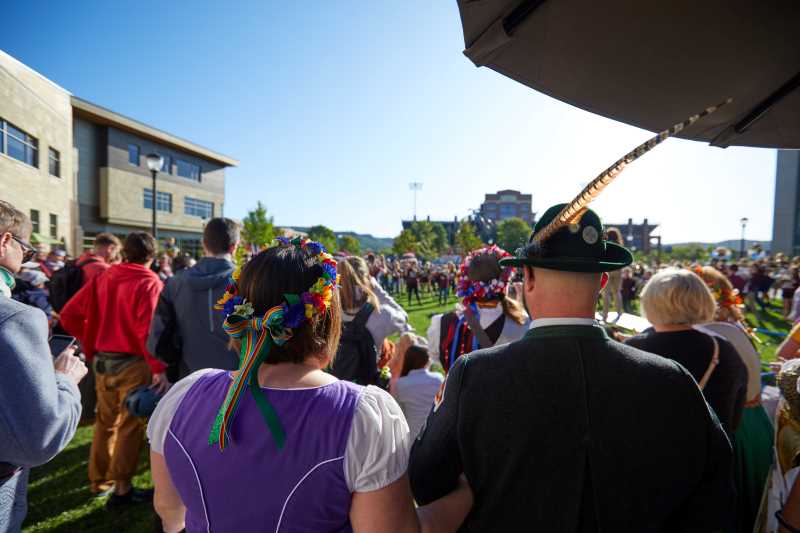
[0,51,78,253]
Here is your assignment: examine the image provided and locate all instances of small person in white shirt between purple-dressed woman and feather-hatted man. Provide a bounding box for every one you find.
[390,333,444,440]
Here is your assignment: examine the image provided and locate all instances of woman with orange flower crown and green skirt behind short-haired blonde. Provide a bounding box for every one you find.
[695,266,774,531]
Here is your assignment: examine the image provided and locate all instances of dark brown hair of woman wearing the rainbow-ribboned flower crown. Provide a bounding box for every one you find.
[232,246,342,364]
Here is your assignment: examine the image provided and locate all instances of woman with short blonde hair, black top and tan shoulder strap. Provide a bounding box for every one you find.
[625,269,747,437]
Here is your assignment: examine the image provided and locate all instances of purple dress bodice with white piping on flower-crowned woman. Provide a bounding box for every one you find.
[164,372,363,532]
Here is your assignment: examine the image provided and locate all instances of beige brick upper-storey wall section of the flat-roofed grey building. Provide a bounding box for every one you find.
[100,167,225,232]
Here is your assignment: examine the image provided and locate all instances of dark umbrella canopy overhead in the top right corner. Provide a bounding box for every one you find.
[458,0,800,148]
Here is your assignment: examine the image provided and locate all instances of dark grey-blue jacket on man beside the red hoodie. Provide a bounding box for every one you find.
[147,257,239,378]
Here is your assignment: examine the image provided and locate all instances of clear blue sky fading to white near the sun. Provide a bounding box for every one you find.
[0,0,776,242]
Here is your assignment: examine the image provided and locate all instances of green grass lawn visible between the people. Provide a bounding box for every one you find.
[24,294,790,533]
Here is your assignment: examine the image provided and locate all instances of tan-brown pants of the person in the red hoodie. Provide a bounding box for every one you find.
[89,359,152,487]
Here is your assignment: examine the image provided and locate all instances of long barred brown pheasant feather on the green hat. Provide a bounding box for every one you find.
[533,98,733,244]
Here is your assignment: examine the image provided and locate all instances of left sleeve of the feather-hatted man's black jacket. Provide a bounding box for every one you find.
[408,356,469,505]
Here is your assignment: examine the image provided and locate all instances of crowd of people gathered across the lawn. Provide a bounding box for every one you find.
[0,196,800,533]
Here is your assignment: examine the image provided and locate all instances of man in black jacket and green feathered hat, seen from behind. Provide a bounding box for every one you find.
[409,205,736,532]
